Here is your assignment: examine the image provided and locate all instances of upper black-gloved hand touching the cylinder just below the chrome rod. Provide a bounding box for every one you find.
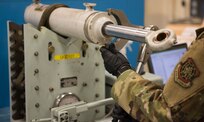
[100,44,131,77]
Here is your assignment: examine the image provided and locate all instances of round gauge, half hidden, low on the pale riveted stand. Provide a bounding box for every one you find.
[53,92,80,107]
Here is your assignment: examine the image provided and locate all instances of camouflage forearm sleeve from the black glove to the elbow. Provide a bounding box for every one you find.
[112,70,172,122]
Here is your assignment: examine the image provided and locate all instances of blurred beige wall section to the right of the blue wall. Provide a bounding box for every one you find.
[145,0,190,28]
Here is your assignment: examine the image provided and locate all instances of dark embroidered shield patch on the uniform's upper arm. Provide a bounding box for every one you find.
[175,58,200,88]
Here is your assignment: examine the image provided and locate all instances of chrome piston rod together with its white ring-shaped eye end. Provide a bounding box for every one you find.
[102,24,176,51]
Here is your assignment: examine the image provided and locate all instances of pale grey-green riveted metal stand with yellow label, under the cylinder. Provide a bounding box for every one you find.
[8,23,105,122]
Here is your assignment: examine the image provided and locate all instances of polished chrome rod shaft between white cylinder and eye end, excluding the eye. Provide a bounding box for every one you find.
[103,24,150,43]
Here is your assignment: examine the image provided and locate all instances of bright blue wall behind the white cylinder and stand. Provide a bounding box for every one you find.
[0,0,144,108]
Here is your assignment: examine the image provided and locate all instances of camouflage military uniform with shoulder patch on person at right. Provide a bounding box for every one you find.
[112,28,204,122]
